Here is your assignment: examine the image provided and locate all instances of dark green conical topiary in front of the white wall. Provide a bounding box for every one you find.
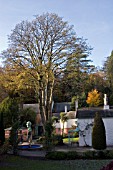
[92,113,106,150]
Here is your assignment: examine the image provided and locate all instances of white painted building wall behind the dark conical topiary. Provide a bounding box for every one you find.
[78,118,113,146]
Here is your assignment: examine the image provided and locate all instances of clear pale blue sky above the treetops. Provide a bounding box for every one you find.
[0,0,113,66]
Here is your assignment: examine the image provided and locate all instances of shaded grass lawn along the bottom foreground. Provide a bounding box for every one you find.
[0,155,111,170]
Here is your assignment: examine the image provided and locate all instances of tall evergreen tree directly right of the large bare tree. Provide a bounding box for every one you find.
[63,52,94,99]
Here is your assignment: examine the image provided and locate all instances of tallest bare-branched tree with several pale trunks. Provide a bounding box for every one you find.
[3,13,90,123]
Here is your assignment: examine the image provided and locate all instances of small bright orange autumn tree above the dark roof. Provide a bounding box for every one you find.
[86,89,102,107]
